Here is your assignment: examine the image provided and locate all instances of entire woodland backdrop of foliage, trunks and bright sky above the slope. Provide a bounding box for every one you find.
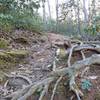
[0,0,100,35]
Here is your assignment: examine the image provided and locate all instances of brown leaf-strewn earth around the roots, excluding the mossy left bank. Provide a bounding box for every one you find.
[0,30,100,100]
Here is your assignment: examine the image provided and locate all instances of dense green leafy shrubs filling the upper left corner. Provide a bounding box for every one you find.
[0,0,42,32]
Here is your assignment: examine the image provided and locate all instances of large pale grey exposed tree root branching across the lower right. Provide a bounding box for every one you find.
[1,44,100,100]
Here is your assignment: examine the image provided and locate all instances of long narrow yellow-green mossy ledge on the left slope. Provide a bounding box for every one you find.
[5,50,28,58]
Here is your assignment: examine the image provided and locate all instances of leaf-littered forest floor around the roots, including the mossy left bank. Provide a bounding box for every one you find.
[0,30,100,100]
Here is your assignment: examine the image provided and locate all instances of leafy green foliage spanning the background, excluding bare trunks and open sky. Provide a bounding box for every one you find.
[0,0,100,36]
